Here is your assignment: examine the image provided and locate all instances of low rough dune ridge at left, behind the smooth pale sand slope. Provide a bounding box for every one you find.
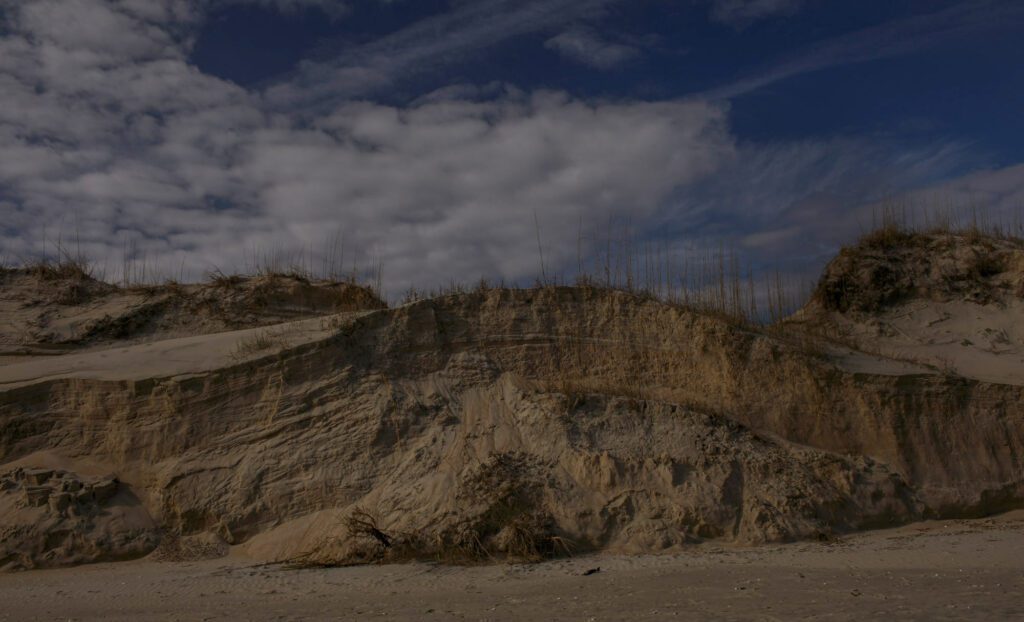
[0,267,386,355]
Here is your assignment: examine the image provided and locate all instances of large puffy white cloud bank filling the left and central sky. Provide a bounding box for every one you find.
[0,0,732,288]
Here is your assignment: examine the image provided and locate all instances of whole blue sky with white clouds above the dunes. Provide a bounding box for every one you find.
[0,0,1024,293]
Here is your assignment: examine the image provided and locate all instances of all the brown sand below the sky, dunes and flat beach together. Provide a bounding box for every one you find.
[0,232,1024,606]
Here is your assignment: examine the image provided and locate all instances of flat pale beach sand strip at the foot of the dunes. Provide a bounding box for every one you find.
[0,512,1024,621]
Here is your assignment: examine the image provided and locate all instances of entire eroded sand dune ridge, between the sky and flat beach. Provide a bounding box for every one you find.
[0,236,1024,570]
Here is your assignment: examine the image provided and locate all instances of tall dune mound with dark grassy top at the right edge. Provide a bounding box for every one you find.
[797,230,1024,384]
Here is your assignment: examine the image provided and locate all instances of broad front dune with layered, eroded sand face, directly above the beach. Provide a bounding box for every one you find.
[0,233,1024,567]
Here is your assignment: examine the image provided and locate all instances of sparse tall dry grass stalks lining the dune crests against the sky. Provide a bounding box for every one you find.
[6,201,1024,328]
